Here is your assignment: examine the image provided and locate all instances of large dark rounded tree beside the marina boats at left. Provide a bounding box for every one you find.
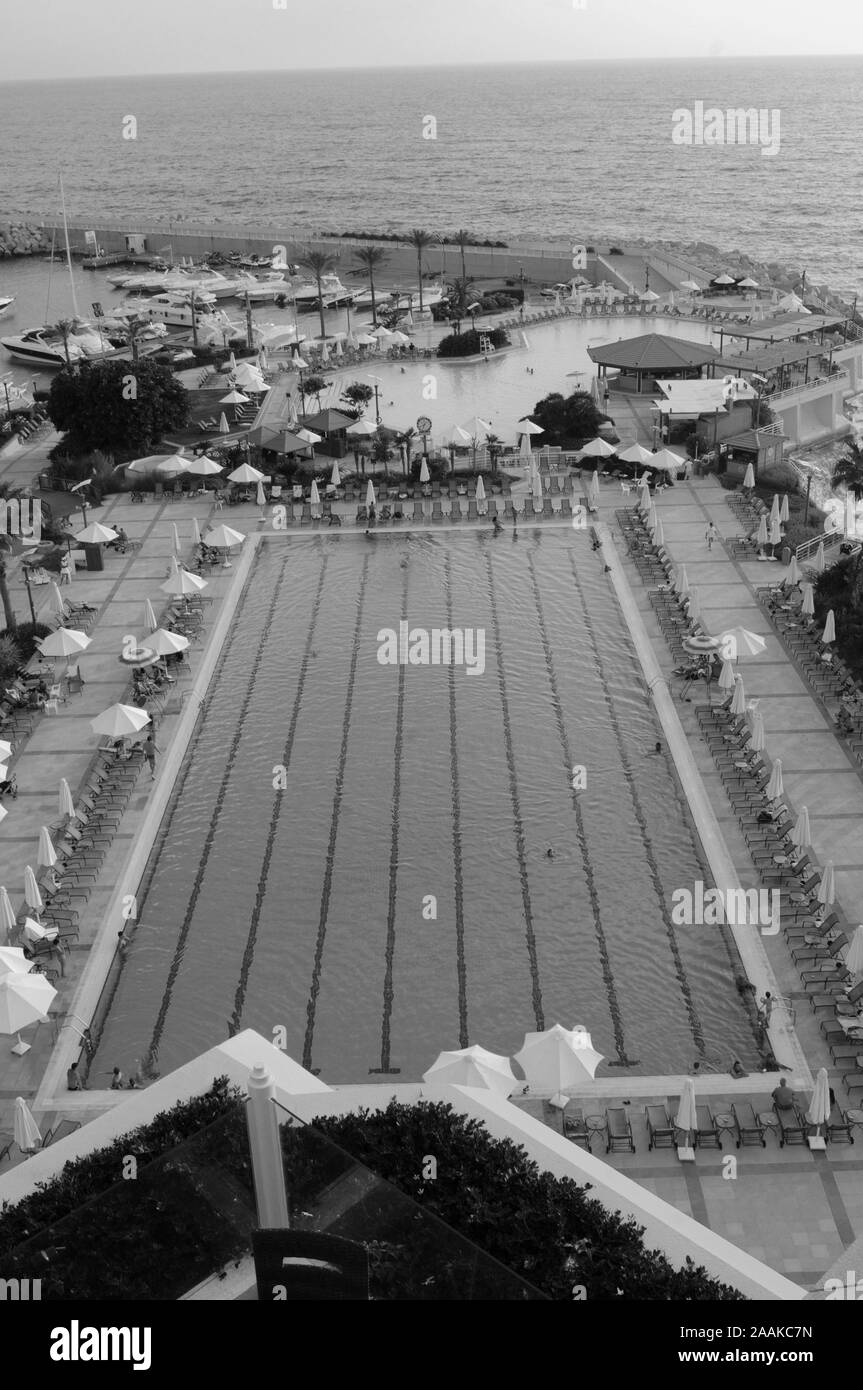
[47,359,189,453]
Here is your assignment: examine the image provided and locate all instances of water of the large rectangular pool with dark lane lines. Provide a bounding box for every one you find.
[94,528,756,1083]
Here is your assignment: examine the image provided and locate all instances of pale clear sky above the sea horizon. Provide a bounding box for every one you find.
[0,0,863,81]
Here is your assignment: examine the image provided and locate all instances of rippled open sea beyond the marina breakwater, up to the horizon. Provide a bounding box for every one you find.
[0,56,863,293]
